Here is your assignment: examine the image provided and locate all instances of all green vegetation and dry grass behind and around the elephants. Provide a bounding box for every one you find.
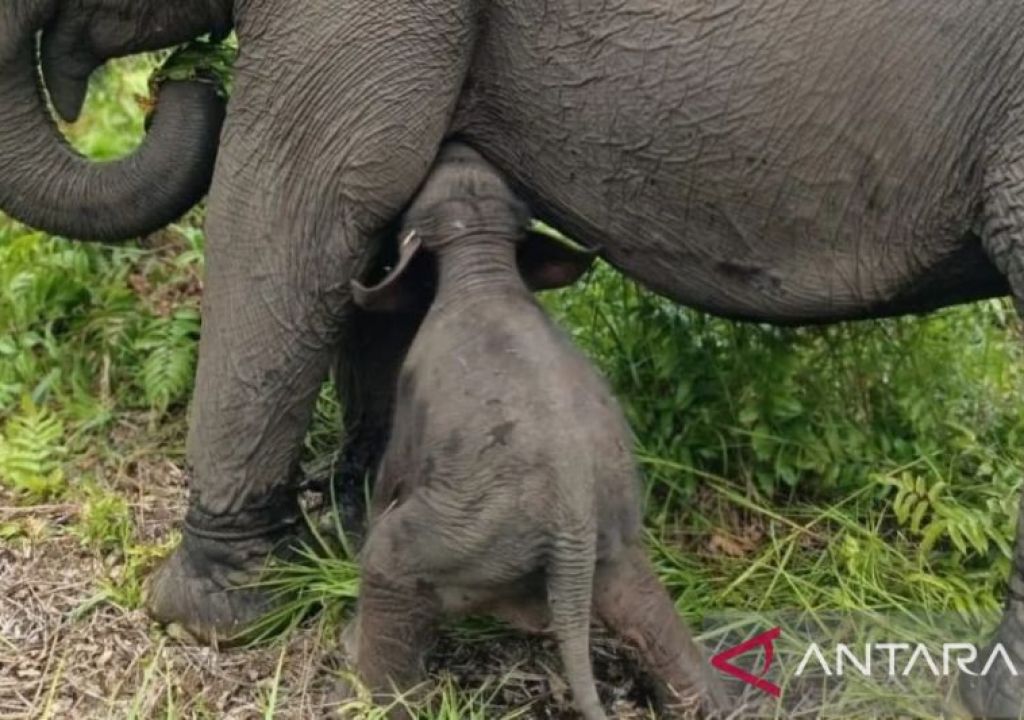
[0,60,1024,717]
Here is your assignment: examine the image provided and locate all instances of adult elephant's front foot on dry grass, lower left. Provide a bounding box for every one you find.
[145,503,299,647]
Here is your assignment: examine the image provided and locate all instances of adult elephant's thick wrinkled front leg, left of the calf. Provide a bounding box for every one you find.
[147,0,474,640]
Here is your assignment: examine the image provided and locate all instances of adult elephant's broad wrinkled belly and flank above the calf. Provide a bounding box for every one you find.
[454,0,1024,323]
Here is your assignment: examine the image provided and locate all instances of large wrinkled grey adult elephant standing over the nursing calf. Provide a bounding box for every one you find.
[0,0,1024,717]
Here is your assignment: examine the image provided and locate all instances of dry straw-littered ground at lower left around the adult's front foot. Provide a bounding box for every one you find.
[0,463,339,720]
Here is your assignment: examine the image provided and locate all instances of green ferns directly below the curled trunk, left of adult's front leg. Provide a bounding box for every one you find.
[0,222,199,483]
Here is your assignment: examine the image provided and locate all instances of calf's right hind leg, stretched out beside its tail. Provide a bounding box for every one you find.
[594,545,729,717]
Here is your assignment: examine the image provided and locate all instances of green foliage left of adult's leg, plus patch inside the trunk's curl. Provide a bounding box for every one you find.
[0,60,202,501]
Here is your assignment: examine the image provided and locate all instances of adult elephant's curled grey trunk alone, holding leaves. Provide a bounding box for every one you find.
[0,0,224,242]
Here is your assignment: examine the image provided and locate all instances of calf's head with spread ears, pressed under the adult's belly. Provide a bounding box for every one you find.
[352,142,597,312]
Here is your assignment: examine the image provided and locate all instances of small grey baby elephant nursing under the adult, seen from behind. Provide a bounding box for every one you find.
[349,143,726,720]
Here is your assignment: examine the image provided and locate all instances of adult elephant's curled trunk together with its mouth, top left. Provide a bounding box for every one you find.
[0,0,230,242]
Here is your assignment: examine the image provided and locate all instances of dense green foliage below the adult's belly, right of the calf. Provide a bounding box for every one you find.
[548,267,1024,499]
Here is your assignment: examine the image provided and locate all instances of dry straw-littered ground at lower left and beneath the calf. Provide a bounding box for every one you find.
[0,448,671,720]
